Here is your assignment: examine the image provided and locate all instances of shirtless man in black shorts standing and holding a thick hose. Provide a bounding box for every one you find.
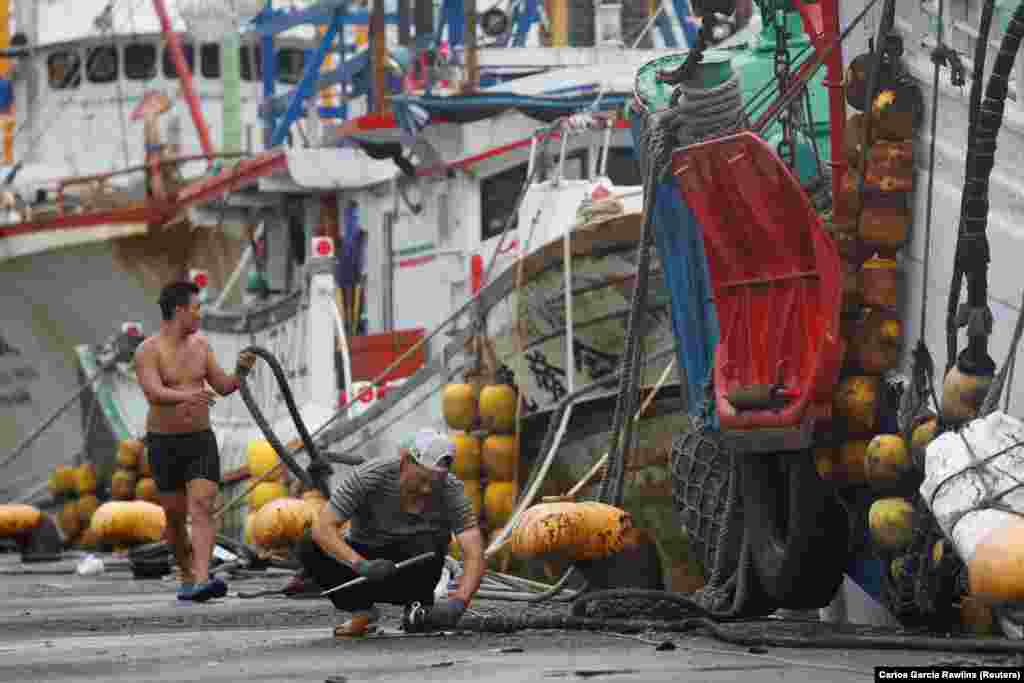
[135,283,256,602]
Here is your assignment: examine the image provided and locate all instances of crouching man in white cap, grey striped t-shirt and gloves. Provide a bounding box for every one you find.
[299,429,484,638]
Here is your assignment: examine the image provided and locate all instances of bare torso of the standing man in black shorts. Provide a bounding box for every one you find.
[136,333,215,434]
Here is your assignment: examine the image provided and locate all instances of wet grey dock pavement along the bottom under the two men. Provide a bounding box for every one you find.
[0,554,1024,683]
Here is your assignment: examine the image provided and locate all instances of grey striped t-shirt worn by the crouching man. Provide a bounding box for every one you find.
[330,456,476,547]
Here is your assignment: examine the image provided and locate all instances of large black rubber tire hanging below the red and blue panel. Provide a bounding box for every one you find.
[739,452,850,609]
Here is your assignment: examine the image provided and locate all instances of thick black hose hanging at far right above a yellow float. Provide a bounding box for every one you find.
[956,1,1024,374]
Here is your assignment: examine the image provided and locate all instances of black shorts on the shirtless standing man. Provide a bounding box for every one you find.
[145,429,220,494]
